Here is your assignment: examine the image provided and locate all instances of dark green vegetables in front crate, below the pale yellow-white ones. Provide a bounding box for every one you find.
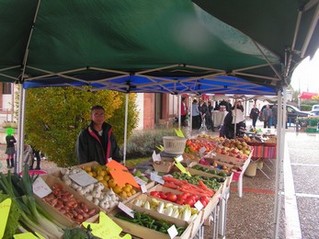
[115,212,185,236]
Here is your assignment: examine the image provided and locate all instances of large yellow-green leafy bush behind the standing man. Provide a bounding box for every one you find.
[25,87,137,167]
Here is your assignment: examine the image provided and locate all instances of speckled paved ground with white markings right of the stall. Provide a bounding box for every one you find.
[0,124,319,239]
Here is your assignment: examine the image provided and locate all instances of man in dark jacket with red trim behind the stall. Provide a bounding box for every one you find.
[76,105,121,165]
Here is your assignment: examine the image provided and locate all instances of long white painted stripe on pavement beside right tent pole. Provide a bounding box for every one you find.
[283,141,302,239]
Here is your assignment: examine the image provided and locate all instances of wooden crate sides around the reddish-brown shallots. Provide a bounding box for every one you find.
[35,175,100,227]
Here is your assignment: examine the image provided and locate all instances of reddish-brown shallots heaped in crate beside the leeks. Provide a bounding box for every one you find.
[43,183,97,224]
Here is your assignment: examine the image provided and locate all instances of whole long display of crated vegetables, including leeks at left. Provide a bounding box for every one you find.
[0,135,252,239]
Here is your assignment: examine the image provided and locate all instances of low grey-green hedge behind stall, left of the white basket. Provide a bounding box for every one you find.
[126,129,176,160]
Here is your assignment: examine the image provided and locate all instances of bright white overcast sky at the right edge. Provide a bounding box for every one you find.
[291,49,319,93]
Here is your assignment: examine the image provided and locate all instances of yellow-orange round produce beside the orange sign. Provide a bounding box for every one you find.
[83,162,137,199]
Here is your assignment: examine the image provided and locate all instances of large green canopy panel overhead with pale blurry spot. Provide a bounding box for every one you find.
[0,0,283,88]
